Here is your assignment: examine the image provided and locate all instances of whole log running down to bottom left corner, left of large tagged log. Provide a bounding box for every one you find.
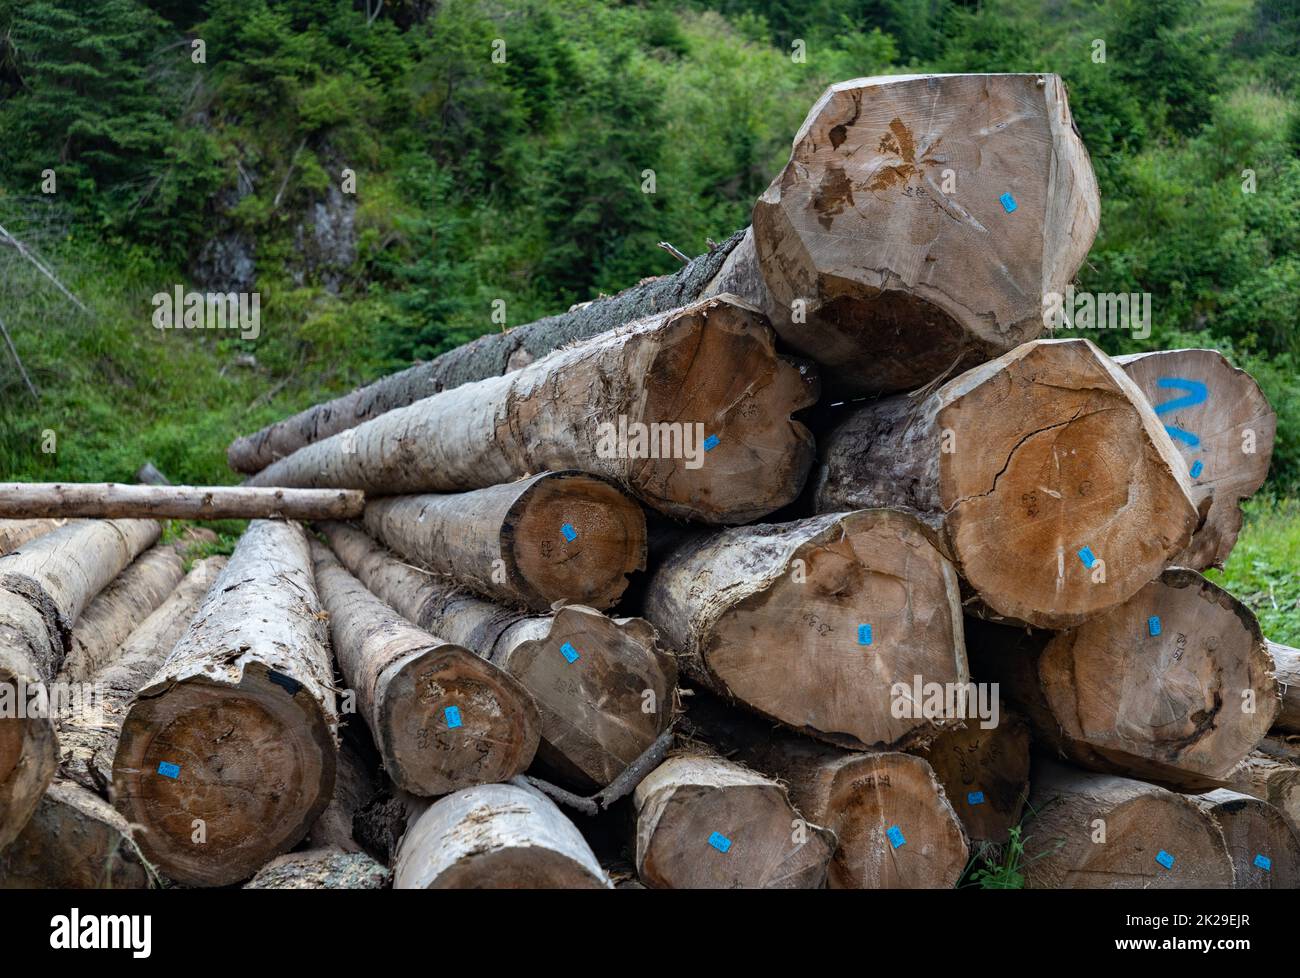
[0,551,225,890]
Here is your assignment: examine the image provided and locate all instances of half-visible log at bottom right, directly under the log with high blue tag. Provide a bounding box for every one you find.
[1022,760,1235,890]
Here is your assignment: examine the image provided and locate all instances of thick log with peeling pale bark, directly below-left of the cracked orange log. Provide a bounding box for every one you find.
[645,510,967,749]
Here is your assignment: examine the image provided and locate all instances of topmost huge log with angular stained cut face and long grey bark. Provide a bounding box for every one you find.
[228,74,1100,472]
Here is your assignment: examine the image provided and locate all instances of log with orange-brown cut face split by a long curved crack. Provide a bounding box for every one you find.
[815,339,1196,628]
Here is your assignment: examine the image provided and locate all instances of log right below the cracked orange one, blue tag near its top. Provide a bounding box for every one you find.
[967,567,1278,791]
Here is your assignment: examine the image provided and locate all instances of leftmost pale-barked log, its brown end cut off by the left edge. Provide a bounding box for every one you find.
[0,520,161,848]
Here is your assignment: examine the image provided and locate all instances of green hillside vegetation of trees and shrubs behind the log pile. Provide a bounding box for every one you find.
[0,0,1300,626]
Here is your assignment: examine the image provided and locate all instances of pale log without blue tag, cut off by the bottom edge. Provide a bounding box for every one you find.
[393,784,614,890]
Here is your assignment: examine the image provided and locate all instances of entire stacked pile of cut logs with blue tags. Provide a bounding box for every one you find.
[0,74,1300,888]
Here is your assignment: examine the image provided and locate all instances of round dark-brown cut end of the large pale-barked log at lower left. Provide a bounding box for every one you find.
[113,653,335,886]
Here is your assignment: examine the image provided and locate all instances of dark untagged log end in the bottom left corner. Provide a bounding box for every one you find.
[0,782,152,890]
